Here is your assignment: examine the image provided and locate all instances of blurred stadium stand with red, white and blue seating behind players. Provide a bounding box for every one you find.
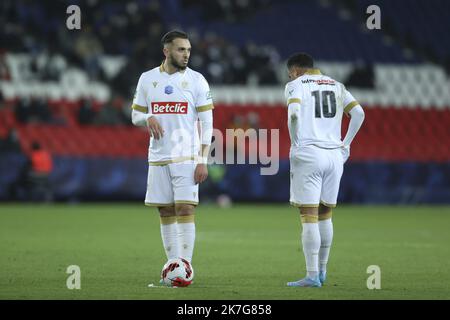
[0,0,450,203]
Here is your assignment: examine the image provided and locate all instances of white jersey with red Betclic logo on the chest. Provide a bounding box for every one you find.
[133,65,214,165]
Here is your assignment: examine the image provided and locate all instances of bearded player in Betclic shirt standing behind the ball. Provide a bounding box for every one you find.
[132,31,214,282]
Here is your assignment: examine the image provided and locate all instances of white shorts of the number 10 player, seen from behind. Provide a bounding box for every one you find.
[290,145,344,208]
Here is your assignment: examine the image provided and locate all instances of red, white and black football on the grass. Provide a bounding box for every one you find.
[161,258,194,287]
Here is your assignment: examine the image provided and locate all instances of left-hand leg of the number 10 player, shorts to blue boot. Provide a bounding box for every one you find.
[288,148,322,287]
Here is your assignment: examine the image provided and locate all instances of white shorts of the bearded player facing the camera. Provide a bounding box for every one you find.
[145,160,198,207]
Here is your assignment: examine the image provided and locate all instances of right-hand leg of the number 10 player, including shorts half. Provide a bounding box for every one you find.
[319,149,343,283]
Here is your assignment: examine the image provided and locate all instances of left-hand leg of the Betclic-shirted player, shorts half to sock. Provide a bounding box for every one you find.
[145,166,180,260]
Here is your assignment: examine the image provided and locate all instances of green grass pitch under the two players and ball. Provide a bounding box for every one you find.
[0,204,450,300]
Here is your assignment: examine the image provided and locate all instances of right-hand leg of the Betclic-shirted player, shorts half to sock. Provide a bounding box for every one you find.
[169,161,198,262]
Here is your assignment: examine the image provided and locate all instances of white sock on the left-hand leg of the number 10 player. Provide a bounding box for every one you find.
[302,222,320,278]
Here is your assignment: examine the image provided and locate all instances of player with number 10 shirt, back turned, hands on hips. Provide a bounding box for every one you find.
[285,53,364,287]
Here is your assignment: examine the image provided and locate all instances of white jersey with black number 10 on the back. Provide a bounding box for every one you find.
[285,69,359,151]
